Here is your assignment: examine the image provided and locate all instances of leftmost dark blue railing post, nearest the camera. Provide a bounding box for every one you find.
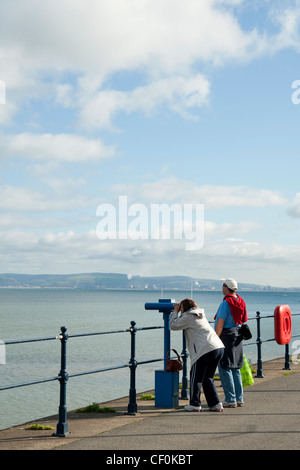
[53,326,70,437]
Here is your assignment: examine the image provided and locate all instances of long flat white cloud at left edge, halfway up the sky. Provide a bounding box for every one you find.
[0,133,115,163]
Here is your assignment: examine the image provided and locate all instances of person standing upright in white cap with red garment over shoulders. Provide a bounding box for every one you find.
[215,278,247,408]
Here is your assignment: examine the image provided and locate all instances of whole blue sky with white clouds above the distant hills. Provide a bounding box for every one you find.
[0,0,300,287]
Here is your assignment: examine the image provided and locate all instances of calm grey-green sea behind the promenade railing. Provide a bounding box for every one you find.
[0,288,300,429]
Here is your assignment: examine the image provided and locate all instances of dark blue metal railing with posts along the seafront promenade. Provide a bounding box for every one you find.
[0,312,300,437]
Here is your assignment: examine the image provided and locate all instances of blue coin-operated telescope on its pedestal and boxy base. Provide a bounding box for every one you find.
[145,299,179,408]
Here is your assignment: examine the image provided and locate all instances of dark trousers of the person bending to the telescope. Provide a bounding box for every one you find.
[190,348,224,408]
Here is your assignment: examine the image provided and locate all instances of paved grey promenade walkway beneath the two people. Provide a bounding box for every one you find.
[0,359,300,451]
